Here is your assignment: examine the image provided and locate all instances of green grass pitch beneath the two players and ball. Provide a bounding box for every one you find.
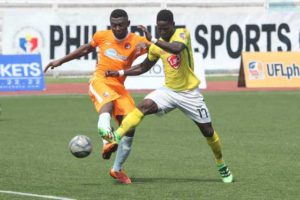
[0,92,300,200]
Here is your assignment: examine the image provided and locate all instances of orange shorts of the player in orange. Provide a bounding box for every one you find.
[89,79,135,117]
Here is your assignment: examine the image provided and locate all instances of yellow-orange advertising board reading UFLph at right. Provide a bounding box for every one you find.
[239,52,300,88]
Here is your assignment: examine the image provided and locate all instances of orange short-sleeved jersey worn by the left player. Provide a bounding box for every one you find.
[90,30,150,85]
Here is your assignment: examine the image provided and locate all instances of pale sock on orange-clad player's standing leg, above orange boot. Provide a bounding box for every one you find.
[113,136,133,171]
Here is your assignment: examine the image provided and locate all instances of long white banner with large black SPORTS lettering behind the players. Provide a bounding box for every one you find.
[3,7,300,88]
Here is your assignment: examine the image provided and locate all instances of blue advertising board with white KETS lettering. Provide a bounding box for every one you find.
[0,54,45,91]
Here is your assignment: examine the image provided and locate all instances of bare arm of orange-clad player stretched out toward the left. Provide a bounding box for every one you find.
[44,44,95,73]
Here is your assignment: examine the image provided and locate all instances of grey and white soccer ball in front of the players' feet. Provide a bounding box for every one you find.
[69,135,92,158]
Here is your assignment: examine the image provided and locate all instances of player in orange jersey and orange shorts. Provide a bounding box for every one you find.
[44,9,150,184]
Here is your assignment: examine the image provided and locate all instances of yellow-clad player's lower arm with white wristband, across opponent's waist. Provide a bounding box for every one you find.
[105,58,157,77]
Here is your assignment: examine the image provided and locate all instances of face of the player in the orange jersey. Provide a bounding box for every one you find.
[110,17,130,39]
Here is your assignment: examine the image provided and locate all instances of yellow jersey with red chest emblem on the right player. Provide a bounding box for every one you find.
[148,28,200,91]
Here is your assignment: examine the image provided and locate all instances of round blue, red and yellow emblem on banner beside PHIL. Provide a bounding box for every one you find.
[13,27,44,54]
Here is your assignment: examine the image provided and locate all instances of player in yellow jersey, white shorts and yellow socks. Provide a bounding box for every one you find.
[103,10,233,183]
